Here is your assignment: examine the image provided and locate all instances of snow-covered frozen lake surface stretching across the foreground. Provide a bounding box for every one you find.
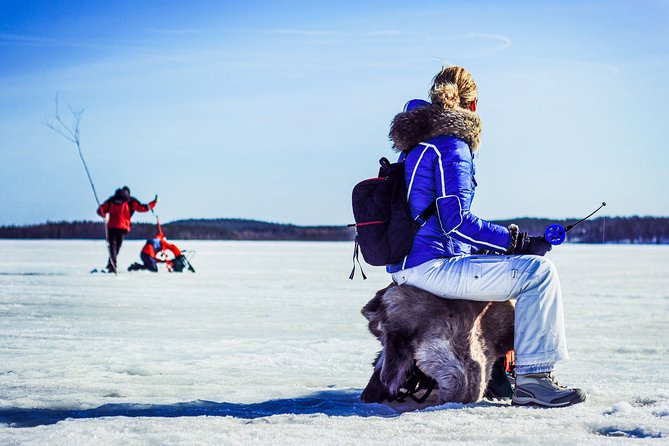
[0,240,669,445]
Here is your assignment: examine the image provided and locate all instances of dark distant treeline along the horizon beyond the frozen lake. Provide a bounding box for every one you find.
[0,217,669,244]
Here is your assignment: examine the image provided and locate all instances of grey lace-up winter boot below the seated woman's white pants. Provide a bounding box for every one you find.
[511,373,585,407]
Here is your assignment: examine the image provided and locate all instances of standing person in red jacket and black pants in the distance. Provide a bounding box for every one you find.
[97,186,158,272]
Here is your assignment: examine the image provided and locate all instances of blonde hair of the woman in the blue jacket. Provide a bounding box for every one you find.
[430,66,478,109]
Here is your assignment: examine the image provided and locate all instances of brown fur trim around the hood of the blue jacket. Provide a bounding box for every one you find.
[388,104,481,153]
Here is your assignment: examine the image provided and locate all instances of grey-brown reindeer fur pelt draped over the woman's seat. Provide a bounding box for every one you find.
[361,284,514,403]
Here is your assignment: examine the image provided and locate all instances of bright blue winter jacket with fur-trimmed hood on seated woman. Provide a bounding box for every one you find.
[386,101,510,273]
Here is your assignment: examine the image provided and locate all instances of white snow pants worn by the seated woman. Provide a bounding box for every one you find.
[392,255,569,366]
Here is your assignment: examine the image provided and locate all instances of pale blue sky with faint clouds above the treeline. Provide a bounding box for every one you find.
[0,0,669,225]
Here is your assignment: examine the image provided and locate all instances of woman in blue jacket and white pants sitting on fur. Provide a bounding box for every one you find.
[387,66,585,407]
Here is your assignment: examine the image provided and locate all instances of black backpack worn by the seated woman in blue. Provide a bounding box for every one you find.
[349,158,436,279]
